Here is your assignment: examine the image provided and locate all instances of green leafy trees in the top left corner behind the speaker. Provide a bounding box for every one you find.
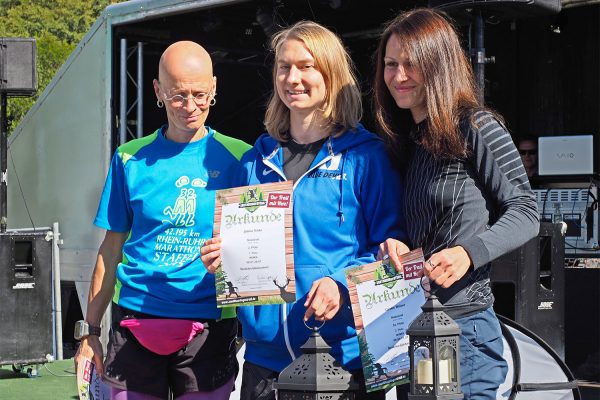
[0,0,122,132]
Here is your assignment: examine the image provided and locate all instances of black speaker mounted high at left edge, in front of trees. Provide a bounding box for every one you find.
[0,38,36,96]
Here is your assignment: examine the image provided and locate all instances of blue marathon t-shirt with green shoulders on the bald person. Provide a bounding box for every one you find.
[94,127,250,319]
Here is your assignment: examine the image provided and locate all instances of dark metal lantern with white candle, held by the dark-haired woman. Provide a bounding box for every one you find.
[406,295,463,400]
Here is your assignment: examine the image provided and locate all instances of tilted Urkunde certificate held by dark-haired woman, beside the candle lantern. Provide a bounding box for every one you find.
[346,249,425,392]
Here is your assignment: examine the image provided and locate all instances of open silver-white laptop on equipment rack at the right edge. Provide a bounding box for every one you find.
[538,135,594,176]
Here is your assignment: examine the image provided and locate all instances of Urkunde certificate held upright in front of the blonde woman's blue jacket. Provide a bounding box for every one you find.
[214,181,296,307]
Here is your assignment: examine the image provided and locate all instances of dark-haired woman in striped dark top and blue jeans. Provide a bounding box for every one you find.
[375,9,539,400]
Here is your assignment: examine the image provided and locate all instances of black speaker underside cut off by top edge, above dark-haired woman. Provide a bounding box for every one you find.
[429,0,561,19]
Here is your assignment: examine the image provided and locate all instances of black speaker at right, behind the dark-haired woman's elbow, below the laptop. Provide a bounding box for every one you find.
[491,222,565,360]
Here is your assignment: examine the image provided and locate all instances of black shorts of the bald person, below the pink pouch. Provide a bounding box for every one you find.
[103,304,238,399]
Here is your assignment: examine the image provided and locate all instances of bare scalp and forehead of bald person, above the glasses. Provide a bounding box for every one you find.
[158,41,213,82]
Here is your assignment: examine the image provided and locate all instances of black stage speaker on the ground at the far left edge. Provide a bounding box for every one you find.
[0,232,53,365]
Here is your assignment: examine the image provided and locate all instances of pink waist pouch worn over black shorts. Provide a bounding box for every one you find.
[120,318,204,356]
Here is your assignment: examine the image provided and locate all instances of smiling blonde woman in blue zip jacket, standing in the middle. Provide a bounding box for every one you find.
[202,21,404,400]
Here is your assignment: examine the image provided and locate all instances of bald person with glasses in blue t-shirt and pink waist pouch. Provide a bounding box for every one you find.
[75,41,250,400]
